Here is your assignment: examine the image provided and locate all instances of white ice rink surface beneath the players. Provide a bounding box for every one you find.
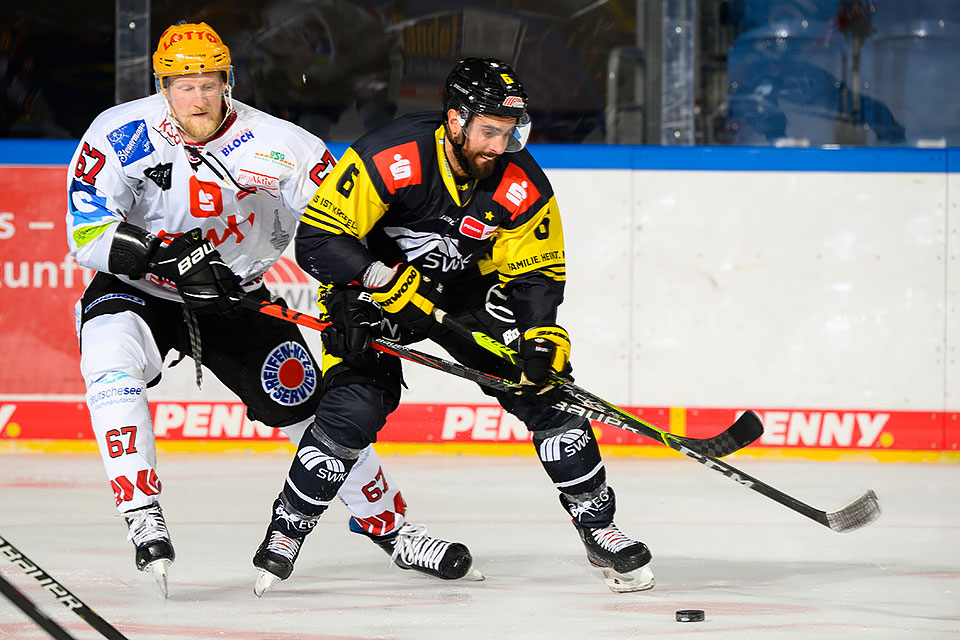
[0,452,960,640]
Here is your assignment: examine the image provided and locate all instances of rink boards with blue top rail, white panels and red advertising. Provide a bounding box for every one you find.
[0,140,960,459]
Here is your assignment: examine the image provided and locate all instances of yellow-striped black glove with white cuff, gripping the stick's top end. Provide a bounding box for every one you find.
[363,262,440,337]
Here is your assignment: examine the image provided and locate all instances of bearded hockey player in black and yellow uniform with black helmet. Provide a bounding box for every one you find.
[254,58,654,592]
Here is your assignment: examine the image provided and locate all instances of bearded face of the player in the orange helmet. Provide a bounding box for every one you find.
[164,72,226,143]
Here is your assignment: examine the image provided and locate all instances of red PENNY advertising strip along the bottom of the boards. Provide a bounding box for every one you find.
[0,396,960,451]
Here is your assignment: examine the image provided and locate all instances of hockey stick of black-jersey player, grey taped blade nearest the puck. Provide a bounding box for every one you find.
[432,308,880,533]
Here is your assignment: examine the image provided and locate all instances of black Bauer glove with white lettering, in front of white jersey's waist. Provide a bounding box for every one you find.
[150,229,243,316]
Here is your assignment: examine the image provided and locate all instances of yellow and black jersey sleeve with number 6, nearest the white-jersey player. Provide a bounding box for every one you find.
[296,147,389,285]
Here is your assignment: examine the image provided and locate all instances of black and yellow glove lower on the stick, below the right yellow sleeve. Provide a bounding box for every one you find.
[519,325,570,404]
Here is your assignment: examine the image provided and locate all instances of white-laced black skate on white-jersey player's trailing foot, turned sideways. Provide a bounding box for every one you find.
[350,517,484,580]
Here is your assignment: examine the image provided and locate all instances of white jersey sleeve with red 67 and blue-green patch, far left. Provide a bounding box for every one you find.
[67,121,138,271]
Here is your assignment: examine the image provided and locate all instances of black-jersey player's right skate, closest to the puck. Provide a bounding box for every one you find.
[560,487,654,593]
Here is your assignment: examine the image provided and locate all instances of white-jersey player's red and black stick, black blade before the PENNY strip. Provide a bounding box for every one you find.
[241,296,763,457]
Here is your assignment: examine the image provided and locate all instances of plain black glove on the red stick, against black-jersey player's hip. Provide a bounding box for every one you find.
[320,289,383,362]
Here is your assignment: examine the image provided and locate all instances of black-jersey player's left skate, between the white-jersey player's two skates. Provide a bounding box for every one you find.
[253,498,320,598]
